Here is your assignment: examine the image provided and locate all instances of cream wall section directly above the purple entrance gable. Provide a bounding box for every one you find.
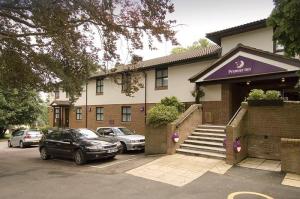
[221,27,273,55]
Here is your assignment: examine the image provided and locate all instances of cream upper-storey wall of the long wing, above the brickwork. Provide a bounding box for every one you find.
[50,58,221,106]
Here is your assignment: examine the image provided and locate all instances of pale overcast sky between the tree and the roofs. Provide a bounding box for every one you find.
[130,0,274,60]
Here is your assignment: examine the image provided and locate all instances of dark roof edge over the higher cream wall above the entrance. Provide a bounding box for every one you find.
[206,19,267,45]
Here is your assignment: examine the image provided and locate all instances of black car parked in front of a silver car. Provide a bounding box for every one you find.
[39,128,120,165]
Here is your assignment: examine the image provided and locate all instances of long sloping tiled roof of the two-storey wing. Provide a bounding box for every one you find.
[90,45,221,78]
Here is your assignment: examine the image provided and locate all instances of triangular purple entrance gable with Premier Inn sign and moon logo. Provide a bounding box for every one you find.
[190,44,300,85]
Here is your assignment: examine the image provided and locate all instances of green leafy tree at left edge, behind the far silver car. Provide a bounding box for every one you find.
[0,87,42,137]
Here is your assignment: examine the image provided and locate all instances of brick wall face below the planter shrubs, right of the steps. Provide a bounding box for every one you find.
[247,102,300,160]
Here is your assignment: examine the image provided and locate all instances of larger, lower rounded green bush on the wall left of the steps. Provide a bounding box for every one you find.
[147,104,179,127]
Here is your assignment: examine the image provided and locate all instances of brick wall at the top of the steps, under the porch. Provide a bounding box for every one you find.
[202,84,232,125]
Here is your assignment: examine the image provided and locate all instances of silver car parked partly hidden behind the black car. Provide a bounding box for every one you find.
[97,127,145,152]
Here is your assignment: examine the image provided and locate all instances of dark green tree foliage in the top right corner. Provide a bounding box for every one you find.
[268,0,300,57]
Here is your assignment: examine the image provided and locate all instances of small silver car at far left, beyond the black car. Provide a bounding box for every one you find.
[8,130,42,148]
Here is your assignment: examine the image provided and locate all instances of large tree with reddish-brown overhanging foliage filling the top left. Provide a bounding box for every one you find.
[0,0,177,99]
